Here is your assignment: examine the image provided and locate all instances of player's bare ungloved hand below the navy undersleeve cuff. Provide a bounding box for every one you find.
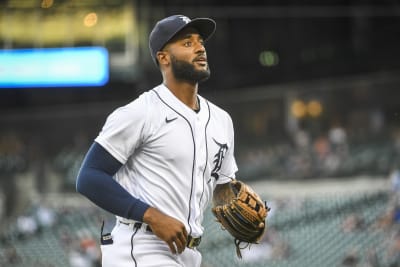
[143,207,188,254]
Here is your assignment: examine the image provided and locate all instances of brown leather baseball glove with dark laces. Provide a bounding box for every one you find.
[212,180,270,258]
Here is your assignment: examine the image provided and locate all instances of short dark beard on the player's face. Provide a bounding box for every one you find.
[171,56,210,83]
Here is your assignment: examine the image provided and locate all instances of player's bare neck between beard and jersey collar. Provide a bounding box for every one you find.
[164,82,199,110]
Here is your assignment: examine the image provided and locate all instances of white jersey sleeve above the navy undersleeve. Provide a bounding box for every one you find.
[95,95,147,164]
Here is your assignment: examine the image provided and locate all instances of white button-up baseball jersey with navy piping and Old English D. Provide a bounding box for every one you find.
[95,85,237,237]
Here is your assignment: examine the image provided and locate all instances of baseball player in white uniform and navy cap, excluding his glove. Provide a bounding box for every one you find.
[76,15,237,267]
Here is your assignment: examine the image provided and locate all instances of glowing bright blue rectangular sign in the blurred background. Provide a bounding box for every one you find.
[0,47,109,88]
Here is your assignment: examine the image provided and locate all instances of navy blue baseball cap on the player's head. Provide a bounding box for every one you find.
[149,15,216,65]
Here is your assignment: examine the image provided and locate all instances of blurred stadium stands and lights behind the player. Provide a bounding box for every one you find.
[0,0,400,267]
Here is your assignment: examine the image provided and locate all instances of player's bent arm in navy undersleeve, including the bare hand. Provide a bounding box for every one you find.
[76,142,187,254]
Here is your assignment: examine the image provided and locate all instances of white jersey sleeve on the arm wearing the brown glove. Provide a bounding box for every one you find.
[217,113,238,184]
